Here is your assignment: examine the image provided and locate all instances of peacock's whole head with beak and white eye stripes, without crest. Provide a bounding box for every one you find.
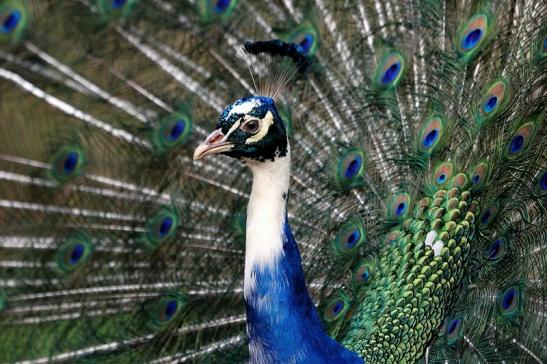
[194,96,288,163]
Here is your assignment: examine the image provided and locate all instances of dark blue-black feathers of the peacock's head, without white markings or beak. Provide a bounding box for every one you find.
[217,96,287,161]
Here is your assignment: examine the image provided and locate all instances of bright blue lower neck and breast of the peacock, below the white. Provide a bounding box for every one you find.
[245,217,363,364]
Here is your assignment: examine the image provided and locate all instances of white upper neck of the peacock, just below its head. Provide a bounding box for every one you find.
[244,144,291,296]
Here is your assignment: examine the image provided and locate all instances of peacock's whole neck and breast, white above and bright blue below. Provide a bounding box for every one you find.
[244,146,362,364]
